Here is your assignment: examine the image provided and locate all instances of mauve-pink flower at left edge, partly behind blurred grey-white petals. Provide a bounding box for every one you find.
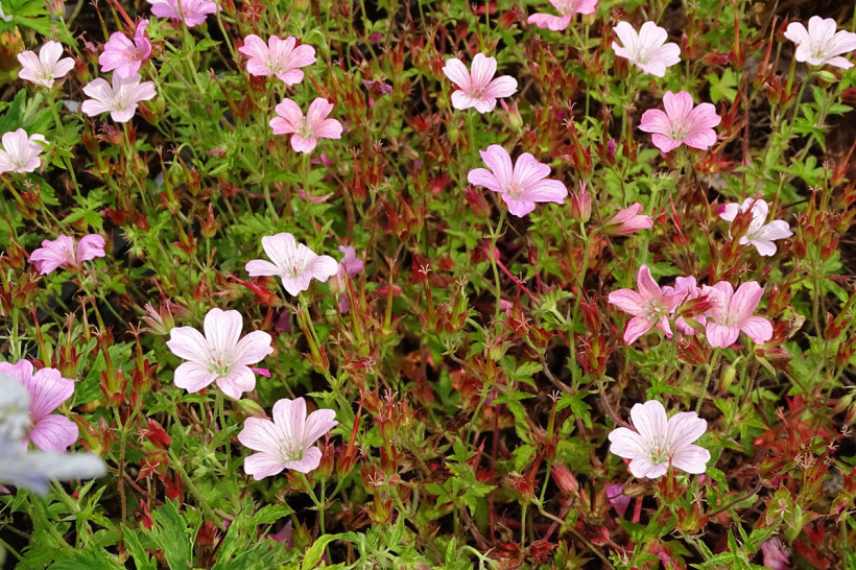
[0,360,79,452]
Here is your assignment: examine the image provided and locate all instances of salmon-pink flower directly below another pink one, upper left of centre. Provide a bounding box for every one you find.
[270,97,342,154]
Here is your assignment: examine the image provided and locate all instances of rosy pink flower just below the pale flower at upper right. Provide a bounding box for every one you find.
[639,91,721,153]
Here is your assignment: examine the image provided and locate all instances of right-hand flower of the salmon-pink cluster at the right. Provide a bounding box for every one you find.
[702,281,773,348]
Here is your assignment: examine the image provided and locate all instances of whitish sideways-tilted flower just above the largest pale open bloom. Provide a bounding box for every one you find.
[246,233,339,296]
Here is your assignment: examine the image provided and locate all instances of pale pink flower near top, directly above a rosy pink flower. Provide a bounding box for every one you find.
[612,22,681,77]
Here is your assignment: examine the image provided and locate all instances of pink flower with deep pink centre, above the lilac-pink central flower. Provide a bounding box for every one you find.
[443,53,517,113]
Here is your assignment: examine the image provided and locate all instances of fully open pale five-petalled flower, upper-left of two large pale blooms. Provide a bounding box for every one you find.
[166,308,273,400]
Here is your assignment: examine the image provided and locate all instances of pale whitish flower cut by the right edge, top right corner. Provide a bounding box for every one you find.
[785,16,856,69]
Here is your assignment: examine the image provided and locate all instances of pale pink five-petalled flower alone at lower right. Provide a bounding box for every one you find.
[609,400,710,479]
